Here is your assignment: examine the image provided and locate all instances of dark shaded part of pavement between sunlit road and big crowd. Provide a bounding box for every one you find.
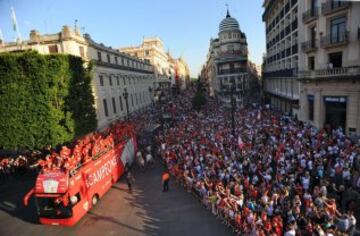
[109,161,232,236]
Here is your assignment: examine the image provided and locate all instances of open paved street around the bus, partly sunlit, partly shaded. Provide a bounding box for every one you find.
[0,160,232,236]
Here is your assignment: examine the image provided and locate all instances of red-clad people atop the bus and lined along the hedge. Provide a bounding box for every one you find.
[0,121,134,179]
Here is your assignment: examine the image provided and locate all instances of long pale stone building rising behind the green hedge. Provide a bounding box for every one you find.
[0,26,155,129]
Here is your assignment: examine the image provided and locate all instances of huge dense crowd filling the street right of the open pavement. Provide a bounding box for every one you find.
[157,90,360,236]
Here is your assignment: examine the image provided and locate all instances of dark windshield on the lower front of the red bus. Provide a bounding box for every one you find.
[36,197,72,219]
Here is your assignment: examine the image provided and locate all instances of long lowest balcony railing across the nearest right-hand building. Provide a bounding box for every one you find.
[299,66,360,79]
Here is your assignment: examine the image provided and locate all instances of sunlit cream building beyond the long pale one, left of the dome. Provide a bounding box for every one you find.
[119,37,190,98]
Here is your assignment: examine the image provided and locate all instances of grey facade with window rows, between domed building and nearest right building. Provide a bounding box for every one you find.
[262,0,303,117]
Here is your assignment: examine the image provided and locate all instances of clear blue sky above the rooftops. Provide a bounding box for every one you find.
[0,0,265,76]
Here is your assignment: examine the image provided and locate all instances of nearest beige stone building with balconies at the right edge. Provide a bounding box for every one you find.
[299,0,360,134]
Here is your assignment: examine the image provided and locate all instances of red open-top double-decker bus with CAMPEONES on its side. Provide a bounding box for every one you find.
[24,124,137,226]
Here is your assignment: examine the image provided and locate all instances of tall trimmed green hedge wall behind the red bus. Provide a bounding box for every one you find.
[0,51,97,149]
